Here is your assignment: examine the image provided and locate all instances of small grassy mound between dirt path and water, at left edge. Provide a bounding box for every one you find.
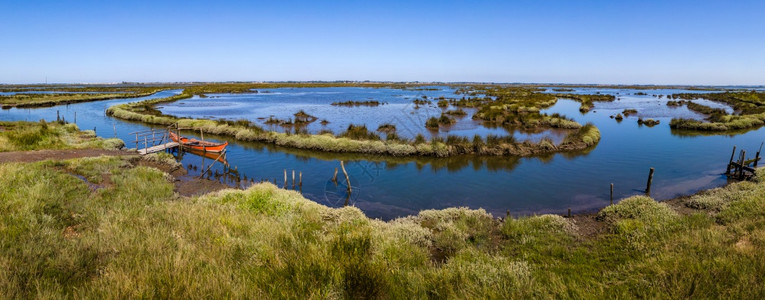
[0,121,125,152]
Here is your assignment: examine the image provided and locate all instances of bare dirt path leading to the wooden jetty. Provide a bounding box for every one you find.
[0,149,138,163]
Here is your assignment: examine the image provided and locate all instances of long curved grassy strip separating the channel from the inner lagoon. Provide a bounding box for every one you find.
[107,89,600,157]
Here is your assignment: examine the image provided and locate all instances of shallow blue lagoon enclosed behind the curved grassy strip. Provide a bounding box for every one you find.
[158,87,563,140]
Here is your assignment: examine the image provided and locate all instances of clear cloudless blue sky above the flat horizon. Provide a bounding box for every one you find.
[0,0,765,85]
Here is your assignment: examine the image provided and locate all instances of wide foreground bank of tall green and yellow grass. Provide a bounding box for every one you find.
[0,157,765,299]
